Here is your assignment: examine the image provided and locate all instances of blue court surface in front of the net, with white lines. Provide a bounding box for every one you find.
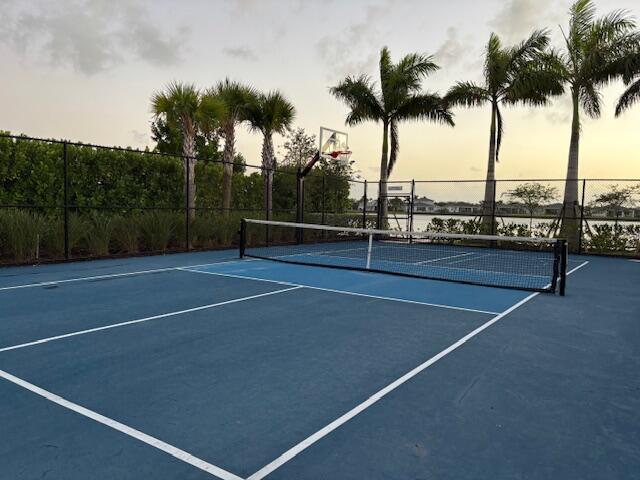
[0,251,640,480]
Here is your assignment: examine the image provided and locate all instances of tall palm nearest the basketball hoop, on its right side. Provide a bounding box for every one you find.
[330,47,454,225]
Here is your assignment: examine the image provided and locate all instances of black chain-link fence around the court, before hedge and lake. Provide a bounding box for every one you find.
[0,134,640,264]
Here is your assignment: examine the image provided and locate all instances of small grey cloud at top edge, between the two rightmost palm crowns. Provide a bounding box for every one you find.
[489,0,567,43]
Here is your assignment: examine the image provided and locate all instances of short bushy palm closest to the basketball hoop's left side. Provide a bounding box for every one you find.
[247,91,296,220]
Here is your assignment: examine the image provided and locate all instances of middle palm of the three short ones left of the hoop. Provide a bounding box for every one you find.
[207,78,257,215]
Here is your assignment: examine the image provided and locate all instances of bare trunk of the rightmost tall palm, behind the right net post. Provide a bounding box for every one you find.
[560,92,580,249]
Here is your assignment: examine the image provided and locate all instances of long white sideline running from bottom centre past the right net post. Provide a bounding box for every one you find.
[247,262,589,480]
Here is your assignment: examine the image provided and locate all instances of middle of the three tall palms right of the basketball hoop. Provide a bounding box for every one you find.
[446,30,563,229]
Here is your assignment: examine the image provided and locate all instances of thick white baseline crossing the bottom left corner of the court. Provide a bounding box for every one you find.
[0,370,242,480]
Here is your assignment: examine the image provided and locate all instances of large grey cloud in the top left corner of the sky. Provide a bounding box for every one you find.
[0,0,187,75]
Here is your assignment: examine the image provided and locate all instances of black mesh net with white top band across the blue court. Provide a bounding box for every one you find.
[240,219,567,295]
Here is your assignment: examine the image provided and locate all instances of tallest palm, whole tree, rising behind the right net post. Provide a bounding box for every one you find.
[558,0,640,248]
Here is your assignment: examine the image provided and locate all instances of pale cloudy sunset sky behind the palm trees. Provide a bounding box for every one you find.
[0,0,640,180]
